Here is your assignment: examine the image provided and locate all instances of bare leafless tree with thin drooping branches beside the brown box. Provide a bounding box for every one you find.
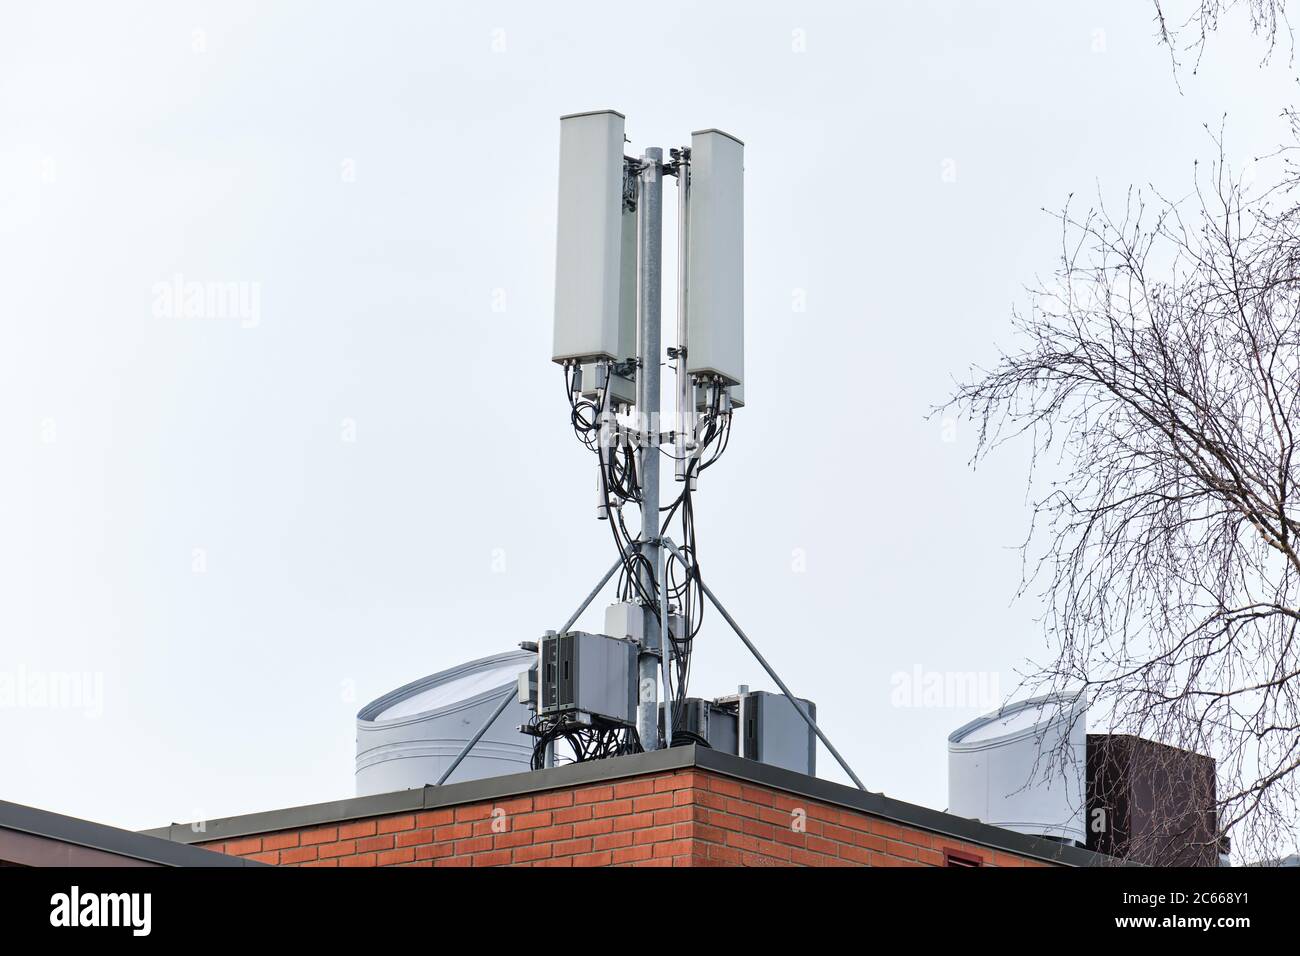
[944,124,1300,857]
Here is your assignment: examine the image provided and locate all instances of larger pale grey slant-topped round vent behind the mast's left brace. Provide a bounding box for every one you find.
[356,650,536,796]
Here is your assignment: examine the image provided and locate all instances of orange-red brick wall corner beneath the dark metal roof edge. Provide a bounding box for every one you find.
[202,769,1047,866]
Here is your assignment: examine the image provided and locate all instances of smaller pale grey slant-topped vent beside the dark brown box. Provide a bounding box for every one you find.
[948,695,1087,845]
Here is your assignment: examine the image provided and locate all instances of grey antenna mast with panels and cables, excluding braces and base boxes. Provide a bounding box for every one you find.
[542,111,745,753]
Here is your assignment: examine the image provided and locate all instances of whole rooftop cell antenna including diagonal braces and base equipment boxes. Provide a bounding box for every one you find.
[438,109,862,788]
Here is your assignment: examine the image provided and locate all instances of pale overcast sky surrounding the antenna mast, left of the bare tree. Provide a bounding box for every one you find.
[0,0,1295,827]
